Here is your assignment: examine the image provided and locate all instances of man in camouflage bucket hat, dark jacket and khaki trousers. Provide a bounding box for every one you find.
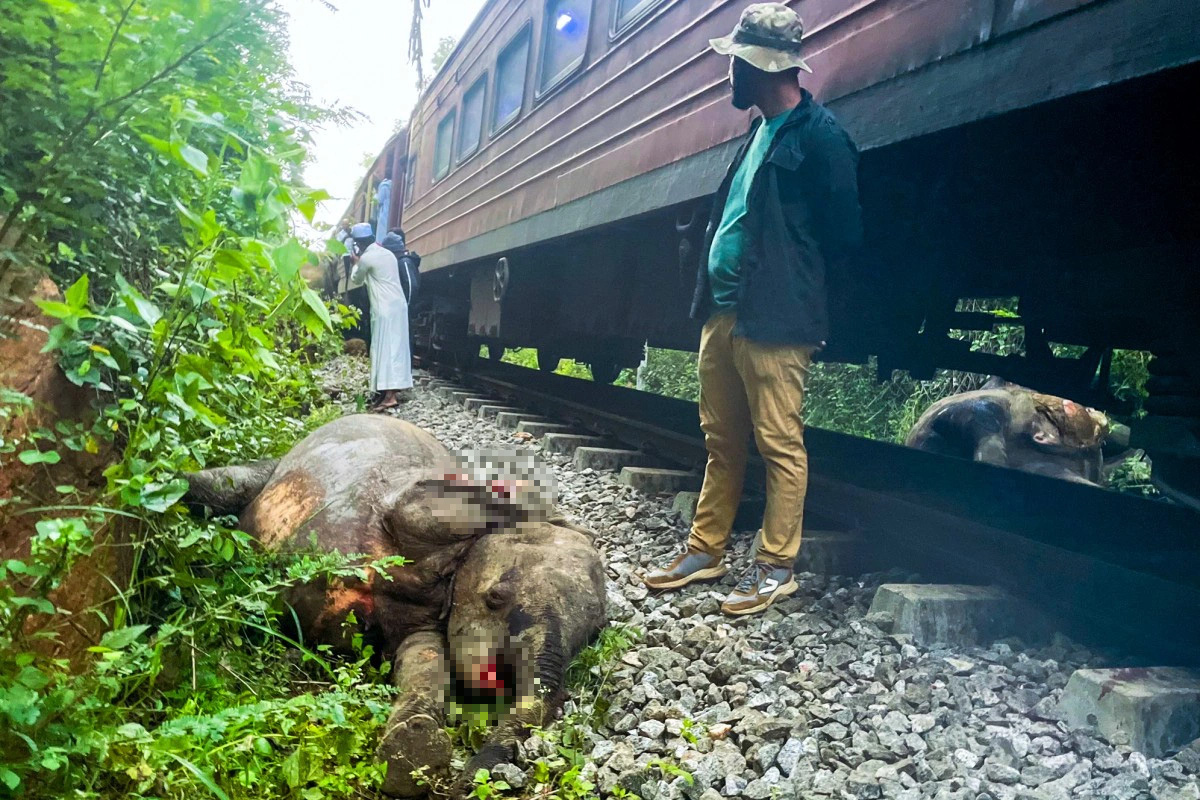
[643,2,862,614]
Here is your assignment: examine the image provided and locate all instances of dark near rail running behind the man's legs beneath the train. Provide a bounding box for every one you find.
[426,352,1200,664]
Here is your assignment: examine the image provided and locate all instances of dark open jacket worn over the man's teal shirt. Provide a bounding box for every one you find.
[691,91,863,345]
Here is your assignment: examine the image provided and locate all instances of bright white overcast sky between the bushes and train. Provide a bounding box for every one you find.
[287,0,484,233]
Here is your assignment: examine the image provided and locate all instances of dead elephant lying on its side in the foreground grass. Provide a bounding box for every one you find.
[185,415,605,795]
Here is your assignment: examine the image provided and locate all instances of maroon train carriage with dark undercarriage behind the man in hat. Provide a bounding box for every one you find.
[333,0,1200,489]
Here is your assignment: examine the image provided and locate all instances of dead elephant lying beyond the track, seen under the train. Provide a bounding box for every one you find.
[906,378,1133,486]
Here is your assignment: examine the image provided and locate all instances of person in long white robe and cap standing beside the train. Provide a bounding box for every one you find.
[350,222,413,411]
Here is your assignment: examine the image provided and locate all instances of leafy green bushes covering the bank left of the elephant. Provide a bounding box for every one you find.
[0,0,390,800]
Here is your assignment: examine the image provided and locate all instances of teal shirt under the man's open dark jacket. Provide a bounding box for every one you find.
[708,112,790,313]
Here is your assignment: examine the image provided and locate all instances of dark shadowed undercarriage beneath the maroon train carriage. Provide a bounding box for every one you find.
[403,65,1200,495]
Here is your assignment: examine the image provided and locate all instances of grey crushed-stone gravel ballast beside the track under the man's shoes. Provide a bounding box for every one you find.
[323,357,1200,800]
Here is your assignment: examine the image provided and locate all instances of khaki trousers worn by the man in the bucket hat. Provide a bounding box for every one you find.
[688,312,816,569]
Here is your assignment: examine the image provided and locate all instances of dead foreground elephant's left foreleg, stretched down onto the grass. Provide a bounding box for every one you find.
[376,631,452,798]
